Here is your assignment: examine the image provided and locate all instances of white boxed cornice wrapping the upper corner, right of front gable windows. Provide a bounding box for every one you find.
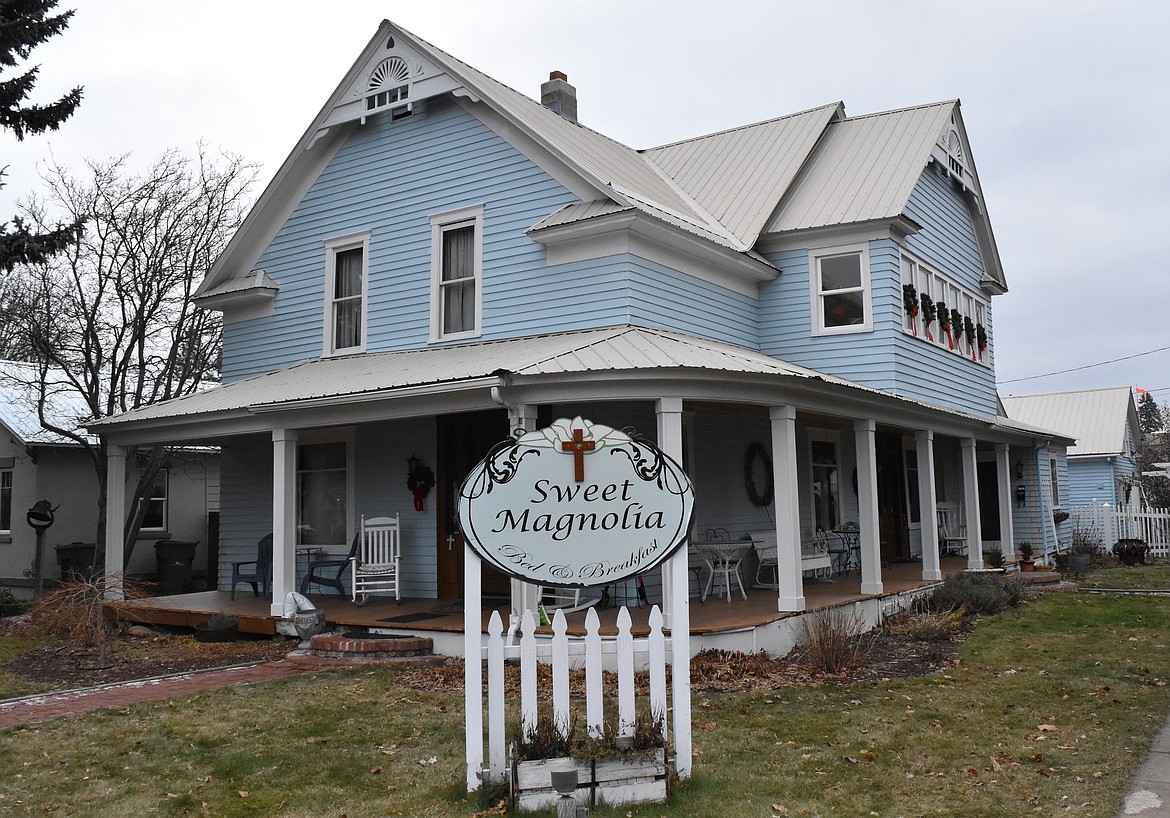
[528,211,779,298]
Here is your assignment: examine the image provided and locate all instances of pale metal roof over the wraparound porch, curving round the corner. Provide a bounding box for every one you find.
[92,325,851,429]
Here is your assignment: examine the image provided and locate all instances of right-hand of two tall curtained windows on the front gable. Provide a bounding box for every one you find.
[431,205,483,341]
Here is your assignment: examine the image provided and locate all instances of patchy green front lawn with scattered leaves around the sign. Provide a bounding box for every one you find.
[0,582,1170,818]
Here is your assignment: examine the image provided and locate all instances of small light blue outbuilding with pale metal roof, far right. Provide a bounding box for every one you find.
[1003,386,1142,507]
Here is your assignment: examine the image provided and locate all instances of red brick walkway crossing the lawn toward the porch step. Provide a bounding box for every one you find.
[0,658,340,729]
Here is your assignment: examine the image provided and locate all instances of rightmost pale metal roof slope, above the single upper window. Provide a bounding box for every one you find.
[764,101,958,233]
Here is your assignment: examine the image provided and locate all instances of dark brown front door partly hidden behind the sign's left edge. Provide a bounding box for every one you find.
[435,410,510,599]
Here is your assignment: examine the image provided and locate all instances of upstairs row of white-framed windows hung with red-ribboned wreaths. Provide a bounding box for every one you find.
[901,255,991,366]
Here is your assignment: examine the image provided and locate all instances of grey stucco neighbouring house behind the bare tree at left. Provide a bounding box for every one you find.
[0,362,219,597]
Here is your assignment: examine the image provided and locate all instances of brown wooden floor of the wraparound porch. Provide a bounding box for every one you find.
[106,556,966,637]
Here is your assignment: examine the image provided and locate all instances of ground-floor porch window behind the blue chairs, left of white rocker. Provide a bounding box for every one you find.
[296,439,353,548]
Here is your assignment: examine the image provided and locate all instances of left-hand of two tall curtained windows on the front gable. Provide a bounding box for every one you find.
[324,232,370,355]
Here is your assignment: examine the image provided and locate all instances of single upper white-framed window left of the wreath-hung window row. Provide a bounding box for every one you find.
[808,245,873,335]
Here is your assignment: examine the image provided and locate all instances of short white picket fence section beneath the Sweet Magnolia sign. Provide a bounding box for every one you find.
[483,605,668,781]
